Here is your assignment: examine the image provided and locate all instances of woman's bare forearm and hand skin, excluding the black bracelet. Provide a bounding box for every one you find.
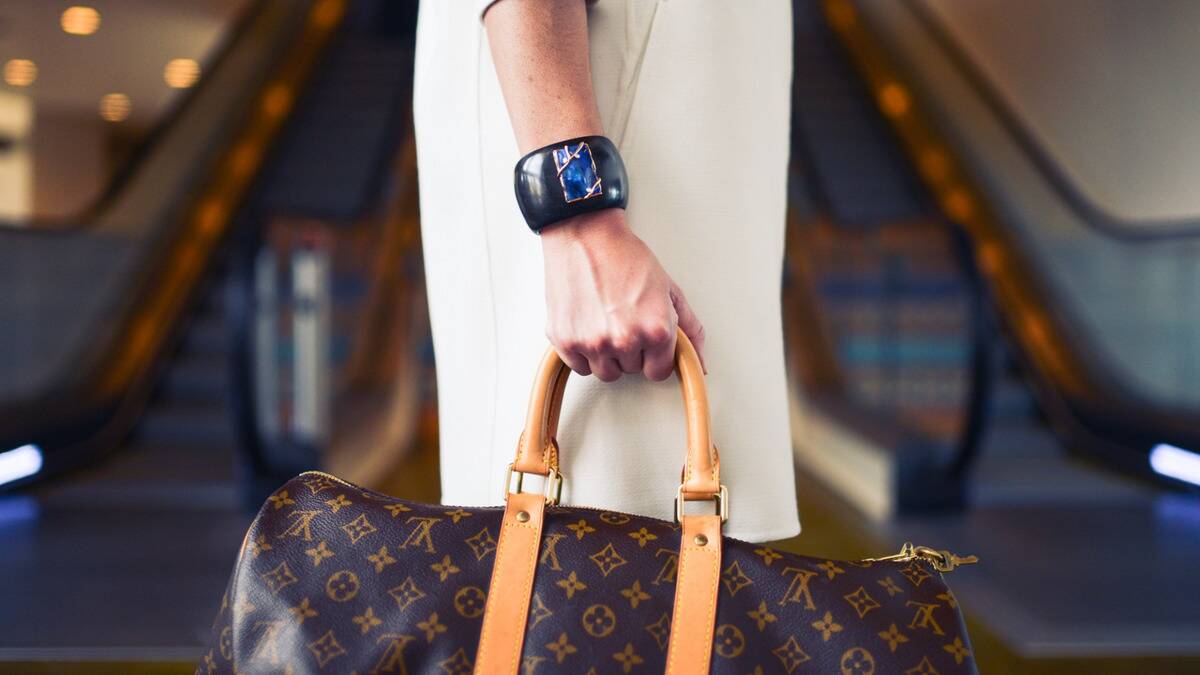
[484,0,704,382]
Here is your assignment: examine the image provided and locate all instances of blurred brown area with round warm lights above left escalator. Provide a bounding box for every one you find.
[0,0,250,227]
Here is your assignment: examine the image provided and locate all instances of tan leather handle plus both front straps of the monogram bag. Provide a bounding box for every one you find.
[475,330,727,675]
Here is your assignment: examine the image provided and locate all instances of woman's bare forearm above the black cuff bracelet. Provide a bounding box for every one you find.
[484,0,604,154]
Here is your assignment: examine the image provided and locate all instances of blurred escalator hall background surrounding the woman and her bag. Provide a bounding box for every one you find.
[0,0,1200,674]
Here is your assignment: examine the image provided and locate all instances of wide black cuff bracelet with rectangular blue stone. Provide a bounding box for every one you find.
[514,136,629,232]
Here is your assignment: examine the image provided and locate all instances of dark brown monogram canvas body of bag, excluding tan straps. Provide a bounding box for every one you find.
[197,473,976,675]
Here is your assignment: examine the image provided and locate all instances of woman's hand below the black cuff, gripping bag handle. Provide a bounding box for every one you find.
[541,209,704,382]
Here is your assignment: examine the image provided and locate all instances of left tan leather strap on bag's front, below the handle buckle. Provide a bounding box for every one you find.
[475,492,546,675]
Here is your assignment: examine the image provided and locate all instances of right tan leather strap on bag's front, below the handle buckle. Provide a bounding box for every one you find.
[666,515,721,675]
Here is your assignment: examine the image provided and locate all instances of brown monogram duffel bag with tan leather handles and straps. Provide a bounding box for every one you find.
[198,333,976,675]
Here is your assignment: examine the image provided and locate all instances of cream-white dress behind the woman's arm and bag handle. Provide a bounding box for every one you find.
[414,0,799,540]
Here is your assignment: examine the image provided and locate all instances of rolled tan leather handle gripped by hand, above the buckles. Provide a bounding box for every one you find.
[512,330,721,500]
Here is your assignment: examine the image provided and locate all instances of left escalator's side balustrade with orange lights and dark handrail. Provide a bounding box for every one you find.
[0,2,341,488]
